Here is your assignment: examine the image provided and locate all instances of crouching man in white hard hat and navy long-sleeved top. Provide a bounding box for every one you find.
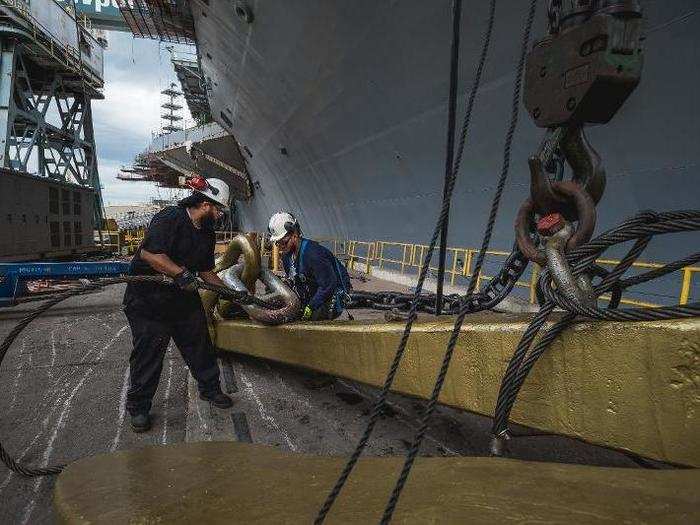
[268,212,352,321]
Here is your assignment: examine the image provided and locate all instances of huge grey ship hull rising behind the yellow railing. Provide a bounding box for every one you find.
[191,0,700,290]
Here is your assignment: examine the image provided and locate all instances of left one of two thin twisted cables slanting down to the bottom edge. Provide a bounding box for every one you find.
[314,0,496,525]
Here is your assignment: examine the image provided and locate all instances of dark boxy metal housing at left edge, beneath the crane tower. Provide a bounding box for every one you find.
[0,170,95,262]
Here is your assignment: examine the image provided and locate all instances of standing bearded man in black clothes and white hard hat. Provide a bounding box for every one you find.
[124,177,233,432]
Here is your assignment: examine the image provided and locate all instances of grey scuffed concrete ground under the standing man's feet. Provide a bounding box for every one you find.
[0,281,664,524]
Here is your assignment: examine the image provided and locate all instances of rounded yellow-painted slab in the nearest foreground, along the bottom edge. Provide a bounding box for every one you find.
[54,442,700,524]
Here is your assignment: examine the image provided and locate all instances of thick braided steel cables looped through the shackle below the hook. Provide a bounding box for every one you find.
[493,210,700,439]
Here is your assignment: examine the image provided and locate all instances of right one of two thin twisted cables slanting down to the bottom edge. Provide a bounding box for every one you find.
[381,0,537,524]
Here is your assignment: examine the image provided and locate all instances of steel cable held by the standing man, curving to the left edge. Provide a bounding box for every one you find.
[0,275,271,477]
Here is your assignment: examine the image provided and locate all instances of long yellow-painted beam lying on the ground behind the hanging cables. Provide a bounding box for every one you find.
[215,314,700,467]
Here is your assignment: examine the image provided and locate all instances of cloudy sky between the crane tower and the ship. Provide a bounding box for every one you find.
[92,31,193,206]
